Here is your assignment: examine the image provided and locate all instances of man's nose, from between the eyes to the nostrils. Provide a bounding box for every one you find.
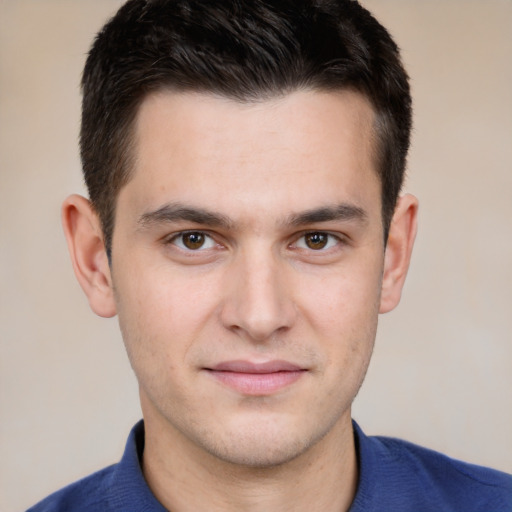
[221,247,297,343]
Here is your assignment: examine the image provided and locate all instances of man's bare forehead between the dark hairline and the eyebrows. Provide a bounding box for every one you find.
[120,87,380,222]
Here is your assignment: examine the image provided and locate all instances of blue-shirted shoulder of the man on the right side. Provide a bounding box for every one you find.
[355,422,512,512]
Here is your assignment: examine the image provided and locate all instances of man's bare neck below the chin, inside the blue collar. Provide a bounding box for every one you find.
[143,411,357,512]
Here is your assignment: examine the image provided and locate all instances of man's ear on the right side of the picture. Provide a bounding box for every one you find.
[379,194,418,313]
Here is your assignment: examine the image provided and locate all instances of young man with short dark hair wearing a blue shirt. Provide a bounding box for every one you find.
[31,0,512,512]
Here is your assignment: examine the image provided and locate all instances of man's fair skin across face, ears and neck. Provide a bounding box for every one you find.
[63,91,417,512]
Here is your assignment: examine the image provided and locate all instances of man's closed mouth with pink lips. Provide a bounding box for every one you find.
[205,361,307,396]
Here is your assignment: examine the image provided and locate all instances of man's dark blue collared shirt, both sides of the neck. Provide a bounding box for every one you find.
[27,421,512,512]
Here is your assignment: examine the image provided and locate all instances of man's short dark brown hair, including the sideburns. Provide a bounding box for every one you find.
[81,0,411,255]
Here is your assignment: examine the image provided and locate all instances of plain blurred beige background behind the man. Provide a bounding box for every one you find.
[0,0,512,512]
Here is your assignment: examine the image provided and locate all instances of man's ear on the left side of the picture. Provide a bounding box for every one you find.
[62,195,116,317]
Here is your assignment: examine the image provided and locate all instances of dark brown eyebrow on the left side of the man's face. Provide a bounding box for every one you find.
[138,203,233,229]
